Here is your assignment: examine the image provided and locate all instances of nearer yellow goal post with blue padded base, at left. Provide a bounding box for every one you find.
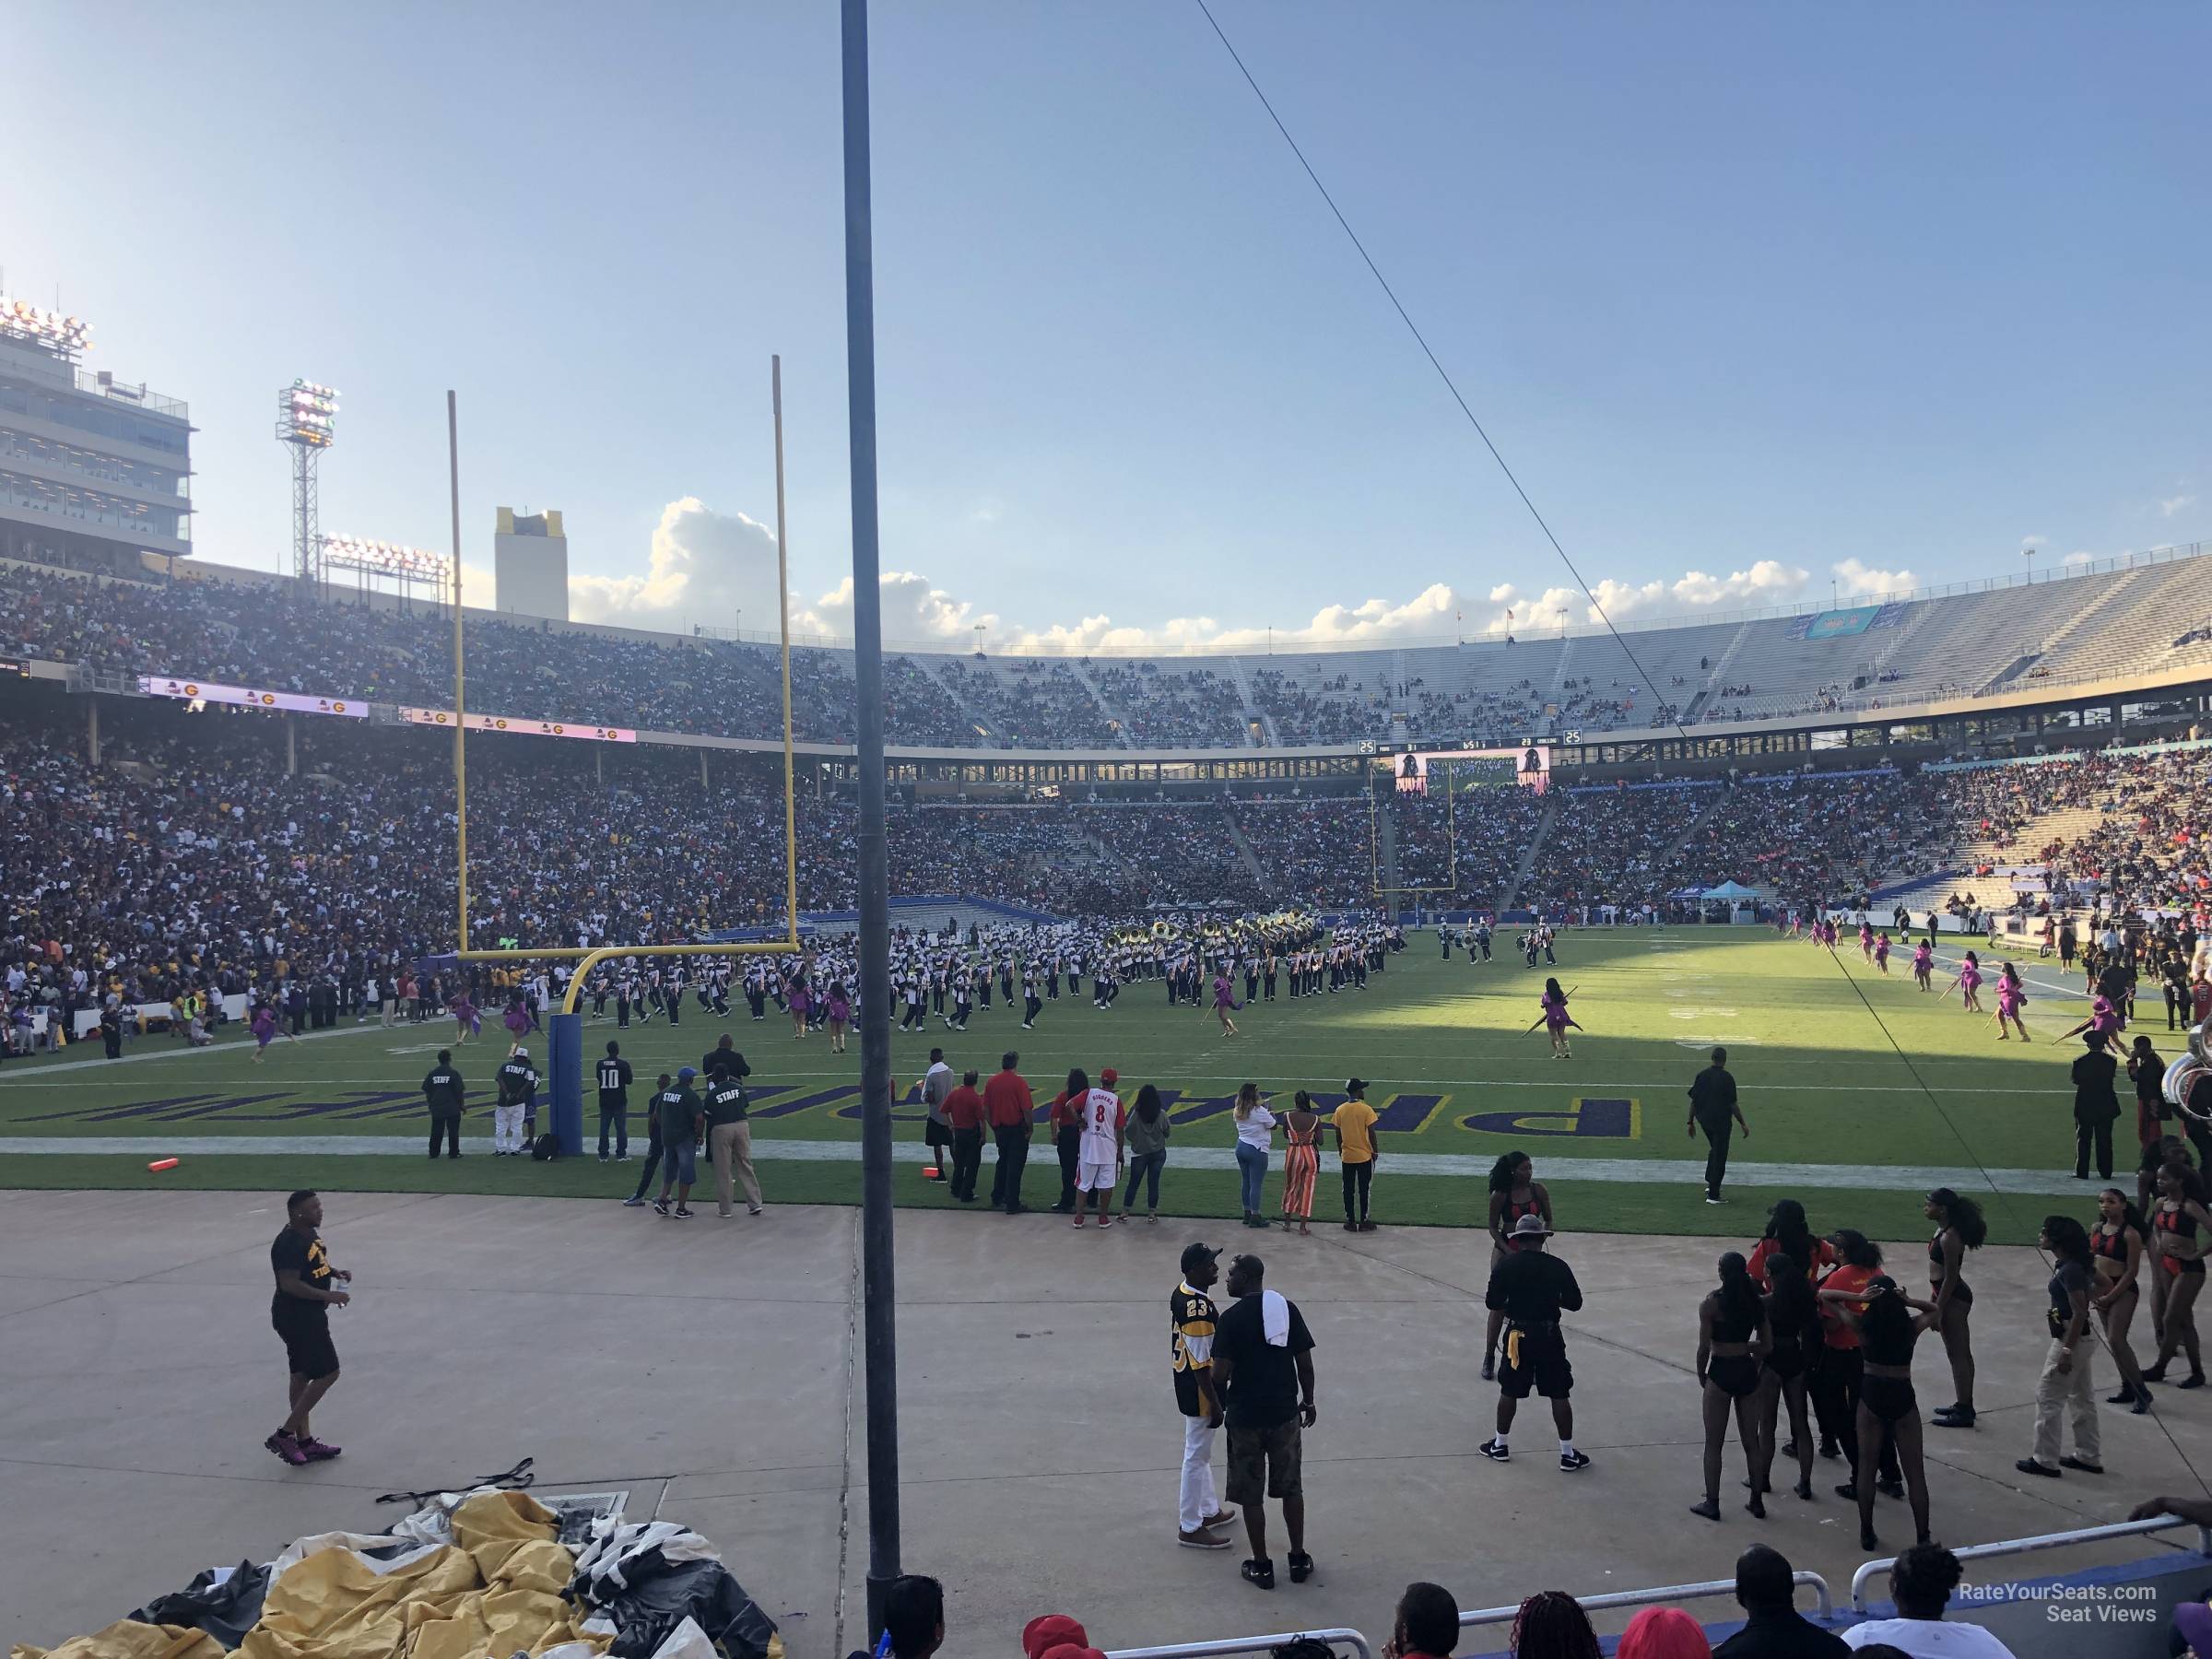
[444,376,803,1157]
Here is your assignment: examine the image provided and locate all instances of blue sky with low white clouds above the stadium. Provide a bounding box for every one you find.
[0,0,2212,651]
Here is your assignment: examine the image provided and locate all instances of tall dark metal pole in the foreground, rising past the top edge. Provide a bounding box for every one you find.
[842,0,898,1648]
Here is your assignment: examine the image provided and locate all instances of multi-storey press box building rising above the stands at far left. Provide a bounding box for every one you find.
[0,299,193,571]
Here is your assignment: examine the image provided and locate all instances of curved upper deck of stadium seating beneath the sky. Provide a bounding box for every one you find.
[0,544,2212,759]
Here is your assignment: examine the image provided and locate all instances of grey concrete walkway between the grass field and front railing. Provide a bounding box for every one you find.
[0,1193,2212,1659]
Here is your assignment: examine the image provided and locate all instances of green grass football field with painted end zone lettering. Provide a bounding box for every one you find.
[0,929,2124,1241]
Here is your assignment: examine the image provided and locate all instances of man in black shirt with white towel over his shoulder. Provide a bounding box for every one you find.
[1212,1256,1316,1591]
